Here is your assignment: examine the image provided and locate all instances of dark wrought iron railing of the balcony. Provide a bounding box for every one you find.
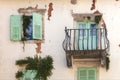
[63,28,109,51]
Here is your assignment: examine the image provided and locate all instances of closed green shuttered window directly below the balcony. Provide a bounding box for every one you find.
[78,68,97,80]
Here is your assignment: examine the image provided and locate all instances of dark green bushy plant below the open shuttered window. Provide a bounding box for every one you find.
[16,56,54,80]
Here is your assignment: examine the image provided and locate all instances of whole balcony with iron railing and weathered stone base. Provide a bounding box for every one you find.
[63,27,109,67]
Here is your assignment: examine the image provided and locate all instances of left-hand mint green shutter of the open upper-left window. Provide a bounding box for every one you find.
[10,15,22,41]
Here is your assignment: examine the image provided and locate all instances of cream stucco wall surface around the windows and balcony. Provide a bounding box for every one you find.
[0,0,120,80]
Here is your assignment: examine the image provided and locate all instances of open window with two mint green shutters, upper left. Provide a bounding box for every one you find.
[10,13,43,41]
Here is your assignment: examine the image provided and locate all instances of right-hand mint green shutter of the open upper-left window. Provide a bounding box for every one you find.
[33,13,42,40]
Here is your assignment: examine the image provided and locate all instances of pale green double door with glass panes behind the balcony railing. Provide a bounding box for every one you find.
[77,22,98,50]
